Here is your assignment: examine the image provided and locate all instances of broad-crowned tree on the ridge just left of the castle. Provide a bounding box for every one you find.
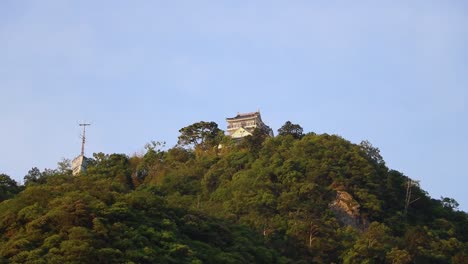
[177,121,223,149]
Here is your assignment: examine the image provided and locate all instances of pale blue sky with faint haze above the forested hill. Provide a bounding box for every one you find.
[0,0,468,211]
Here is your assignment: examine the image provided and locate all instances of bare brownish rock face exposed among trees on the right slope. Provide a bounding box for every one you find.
[330,191,364,229]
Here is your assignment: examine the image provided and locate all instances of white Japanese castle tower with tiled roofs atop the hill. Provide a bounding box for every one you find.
[226,111,273,138]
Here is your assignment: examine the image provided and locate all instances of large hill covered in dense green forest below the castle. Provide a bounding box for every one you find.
[0,122,468,263]
